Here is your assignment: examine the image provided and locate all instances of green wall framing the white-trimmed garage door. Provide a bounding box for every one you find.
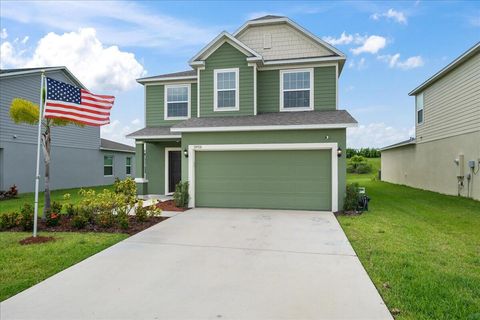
[182,129,346,208]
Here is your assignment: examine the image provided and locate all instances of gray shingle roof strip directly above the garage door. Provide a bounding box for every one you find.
[172,110,357,129]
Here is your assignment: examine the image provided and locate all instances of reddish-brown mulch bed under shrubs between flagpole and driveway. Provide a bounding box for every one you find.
[8,215,168,238]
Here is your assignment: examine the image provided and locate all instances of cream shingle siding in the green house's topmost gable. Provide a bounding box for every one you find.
[238,24,332,60]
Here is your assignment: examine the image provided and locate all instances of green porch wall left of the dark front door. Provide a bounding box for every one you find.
[145,141,180,194]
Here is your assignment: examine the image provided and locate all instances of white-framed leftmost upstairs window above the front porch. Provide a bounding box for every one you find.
[165,84,190,120]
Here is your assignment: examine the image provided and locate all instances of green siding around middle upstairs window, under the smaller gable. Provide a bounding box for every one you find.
[200,43,254,117]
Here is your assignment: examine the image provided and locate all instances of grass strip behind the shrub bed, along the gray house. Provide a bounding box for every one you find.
[0,185,113,215]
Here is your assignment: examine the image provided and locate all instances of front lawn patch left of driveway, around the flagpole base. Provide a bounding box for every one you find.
[0,232,128,301]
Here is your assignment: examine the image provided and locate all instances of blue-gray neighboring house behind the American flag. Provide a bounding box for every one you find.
[0,67,135,192]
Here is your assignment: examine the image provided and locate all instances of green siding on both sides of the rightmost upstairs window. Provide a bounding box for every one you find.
[257,66,337,113]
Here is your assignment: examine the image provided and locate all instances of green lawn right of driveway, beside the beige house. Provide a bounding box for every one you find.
[339,159,480,320]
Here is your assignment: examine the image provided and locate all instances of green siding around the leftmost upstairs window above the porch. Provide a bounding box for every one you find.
[144,81,197,127]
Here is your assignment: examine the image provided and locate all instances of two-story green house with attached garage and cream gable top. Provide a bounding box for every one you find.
[128,16,357,211]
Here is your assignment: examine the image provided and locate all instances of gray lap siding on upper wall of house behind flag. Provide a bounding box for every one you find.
[0,70,100,149]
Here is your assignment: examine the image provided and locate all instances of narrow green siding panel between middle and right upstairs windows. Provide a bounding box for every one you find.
[257,70,280,113]
